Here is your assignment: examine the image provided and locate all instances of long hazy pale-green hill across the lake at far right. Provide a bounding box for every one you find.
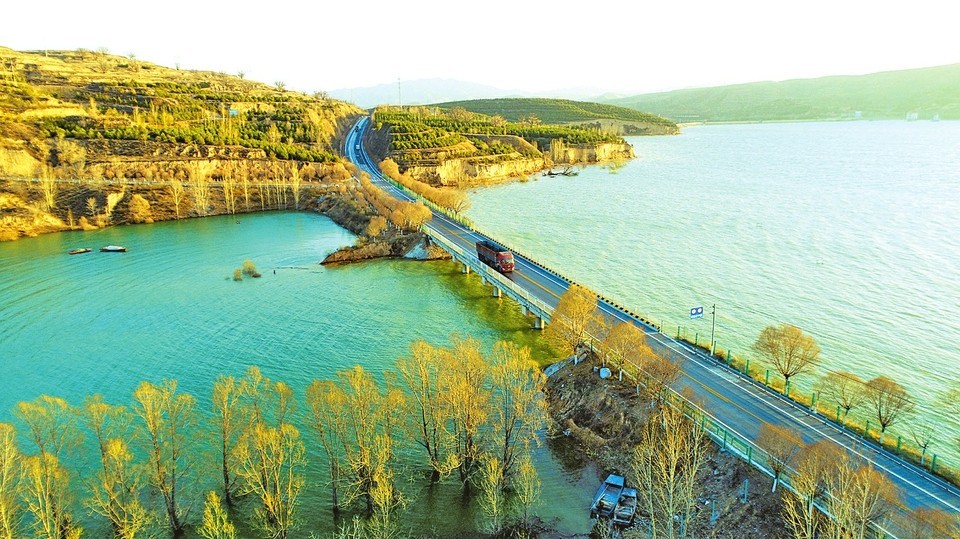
[608,64,960,122]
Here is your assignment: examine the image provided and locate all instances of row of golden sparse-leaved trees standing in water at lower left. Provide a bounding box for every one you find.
[0,337,547,539]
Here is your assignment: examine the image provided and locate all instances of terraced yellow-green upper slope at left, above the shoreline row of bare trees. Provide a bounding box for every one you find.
[0,48,362,176]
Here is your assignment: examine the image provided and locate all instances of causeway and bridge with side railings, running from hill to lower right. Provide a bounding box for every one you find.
[344,118,960,537]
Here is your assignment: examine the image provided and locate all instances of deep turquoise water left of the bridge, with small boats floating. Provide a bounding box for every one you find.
[0,213,596,533]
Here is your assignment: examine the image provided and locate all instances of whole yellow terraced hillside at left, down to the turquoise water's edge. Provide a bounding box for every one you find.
[0,48,363,241]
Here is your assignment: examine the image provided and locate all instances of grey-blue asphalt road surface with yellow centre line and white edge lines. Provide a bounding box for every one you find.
[345,118,960,528]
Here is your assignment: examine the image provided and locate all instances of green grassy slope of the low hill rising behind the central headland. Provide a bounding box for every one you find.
[435,98,673,126]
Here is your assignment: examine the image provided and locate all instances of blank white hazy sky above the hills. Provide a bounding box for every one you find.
[0,0,960,93]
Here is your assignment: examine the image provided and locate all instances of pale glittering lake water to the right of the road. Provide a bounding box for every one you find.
[468,122,960,465]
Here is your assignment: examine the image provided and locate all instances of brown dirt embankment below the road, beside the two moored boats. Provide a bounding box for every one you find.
[546,359,787,539]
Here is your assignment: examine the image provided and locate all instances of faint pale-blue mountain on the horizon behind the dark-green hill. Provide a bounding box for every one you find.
[330,79,611,108]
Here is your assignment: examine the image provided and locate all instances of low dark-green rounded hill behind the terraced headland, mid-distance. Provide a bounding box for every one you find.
[433,98,678,135]
